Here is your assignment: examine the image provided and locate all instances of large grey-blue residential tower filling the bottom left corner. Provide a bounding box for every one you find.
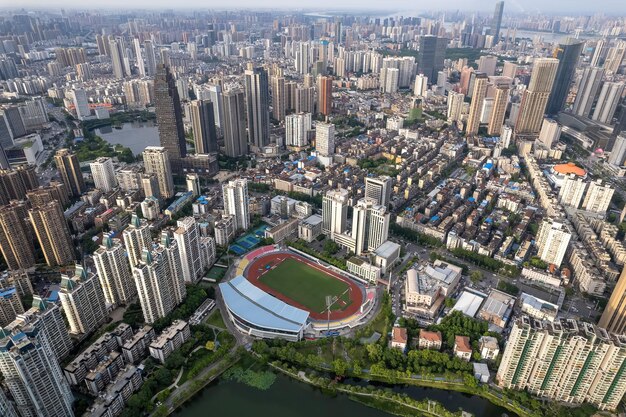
[0,326,74,417]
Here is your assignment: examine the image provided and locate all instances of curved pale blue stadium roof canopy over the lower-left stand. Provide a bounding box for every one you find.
[219,275,309,332]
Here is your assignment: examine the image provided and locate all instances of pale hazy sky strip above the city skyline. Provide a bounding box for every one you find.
[7,0,626,15]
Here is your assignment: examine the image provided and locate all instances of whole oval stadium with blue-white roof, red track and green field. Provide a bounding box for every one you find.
[220,245,376,340]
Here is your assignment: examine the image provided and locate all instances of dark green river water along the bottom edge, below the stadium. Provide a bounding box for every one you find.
[173,374,513,417]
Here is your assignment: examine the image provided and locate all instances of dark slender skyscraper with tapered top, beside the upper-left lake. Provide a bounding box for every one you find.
[154,64,187,171]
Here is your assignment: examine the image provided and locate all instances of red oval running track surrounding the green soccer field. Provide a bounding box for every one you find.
[244,252,363,321]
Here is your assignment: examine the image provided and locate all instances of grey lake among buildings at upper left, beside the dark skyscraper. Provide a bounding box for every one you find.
[95,121,159,155]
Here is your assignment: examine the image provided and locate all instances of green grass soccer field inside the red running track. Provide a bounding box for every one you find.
[259,259,352,313]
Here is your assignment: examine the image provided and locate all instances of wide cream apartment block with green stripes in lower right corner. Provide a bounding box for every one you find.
[496,315,626,410]
